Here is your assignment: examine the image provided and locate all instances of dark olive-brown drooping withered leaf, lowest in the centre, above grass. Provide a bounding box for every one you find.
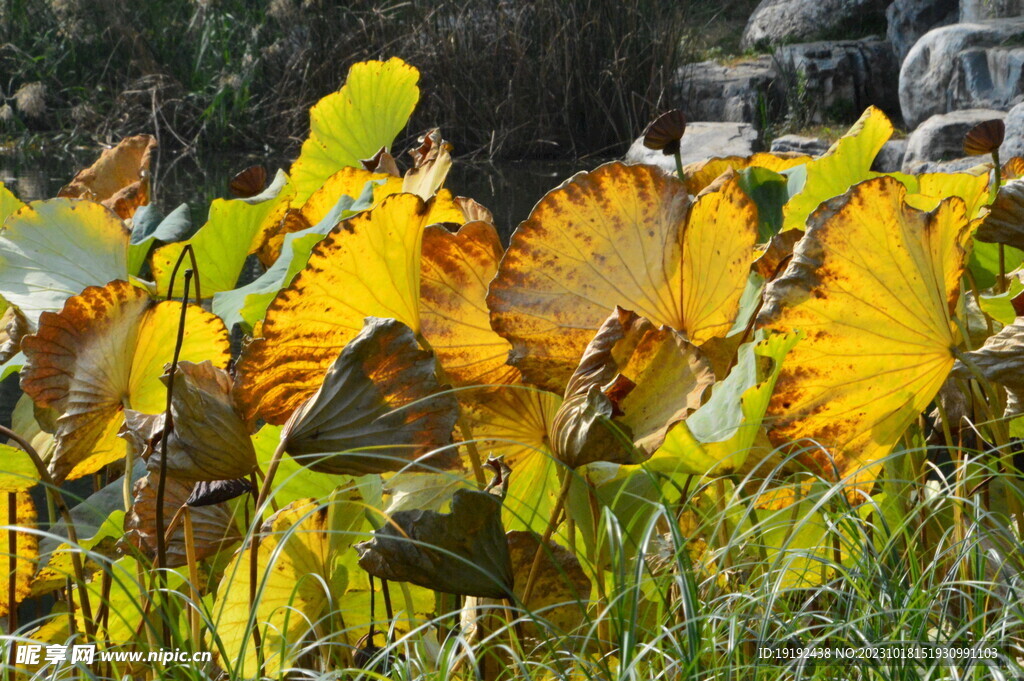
[355,483,514,598]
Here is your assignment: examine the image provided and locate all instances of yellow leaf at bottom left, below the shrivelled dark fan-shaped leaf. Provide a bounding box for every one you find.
[213,492,365,678]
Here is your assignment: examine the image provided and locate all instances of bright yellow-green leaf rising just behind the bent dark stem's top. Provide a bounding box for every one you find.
[151,171,291,298]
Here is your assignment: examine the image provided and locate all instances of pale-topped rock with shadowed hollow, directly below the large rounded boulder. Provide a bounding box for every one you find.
[903,109,1006,173]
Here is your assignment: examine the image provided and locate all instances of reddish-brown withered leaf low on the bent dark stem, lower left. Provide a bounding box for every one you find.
[123,471,242,567]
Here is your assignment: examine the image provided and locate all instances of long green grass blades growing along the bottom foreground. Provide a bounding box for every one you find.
[4,428,1024,681]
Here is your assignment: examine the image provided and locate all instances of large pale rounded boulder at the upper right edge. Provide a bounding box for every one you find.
[899,17,1024,128]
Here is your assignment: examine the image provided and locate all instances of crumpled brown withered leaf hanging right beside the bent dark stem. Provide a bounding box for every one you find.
[125,360,256,481]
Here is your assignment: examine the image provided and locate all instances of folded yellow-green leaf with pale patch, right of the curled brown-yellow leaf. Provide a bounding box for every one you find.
[644,334,800,475]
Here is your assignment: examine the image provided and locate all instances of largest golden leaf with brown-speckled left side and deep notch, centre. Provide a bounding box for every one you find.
[487,163,758,392]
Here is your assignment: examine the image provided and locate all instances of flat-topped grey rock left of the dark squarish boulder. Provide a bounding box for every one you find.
[678,54,783,128]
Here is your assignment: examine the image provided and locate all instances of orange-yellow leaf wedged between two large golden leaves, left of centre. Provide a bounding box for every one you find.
[420,222,519,385]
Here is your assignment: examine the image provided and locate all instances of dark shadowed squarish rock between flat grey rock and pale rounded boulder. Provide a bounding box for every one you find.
[775,40,899,123]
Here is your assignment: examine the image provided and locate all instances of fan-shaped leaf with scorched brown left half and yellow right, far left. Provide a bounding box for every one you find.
[22,282,229,482]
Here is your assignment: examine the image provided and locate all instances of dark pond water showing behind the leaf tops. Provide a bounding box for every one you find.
[0,150,600,243]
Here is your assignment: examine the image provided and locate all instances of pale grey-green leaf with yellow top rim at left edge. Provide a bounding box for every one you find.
[0,199,128,329]
